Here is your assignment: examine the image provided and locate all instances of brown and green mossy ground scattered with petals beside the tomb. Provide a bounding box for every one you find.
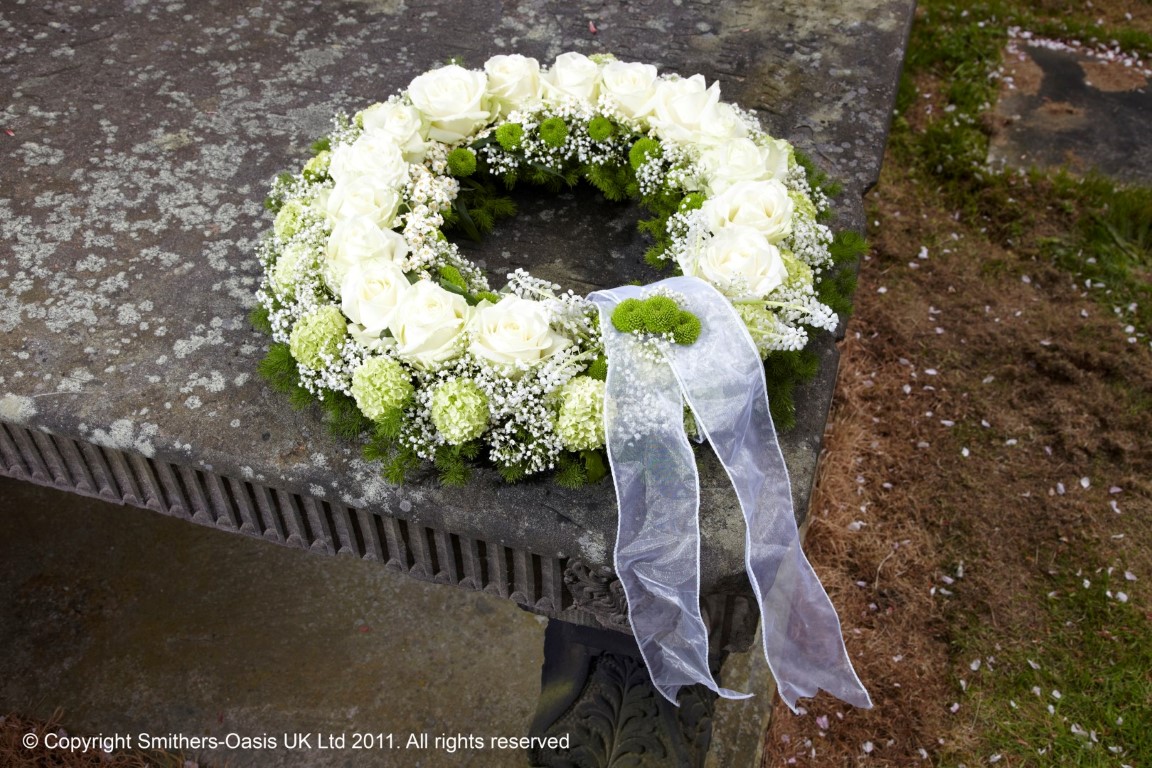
[764,0,1152,768]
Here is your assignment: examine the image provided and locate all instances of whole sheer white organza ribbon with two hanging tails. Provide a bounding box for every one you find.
[590,277,872,712]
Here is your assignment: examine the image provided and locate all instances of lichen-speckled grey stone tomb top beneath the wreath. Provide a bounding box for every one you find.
[0,0,911,630]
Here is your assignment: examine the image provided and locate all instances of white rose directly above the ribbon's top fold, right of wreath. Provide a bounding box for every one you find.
[682,225,788,299]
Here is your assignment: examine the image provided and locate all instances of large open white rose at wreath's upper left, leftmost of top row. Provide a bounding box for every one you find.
[408,64,492,144]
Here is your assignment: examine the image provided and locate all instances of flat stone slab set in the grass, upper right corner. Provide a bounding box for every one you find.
[988,39,1152,185]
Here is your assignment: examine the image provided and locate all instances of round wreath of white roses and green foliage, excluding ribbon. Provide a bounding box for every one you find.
[253,53,862,486]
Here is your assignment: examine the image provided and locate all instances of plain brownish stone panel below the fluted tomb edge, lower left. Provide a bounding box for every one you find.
[0,478,546,768]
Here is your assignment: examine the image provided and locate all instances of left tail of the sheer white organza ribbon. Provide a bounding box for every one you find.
[592,288,743,705]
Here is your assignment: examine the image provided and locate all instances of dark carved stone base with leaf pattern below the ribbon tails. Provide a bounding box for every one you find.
[529,621,720,768]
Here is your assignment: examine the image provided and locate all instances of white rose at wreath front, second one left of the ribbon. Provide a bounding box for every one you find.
[388,280,471,368]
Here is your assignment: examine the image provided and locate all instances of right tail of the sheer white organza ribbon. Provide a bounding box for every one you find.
[669,272,872,712]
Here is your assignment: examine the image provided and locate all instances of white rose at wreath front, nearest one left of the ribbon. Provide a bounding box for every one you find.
[469,295,571,368]
